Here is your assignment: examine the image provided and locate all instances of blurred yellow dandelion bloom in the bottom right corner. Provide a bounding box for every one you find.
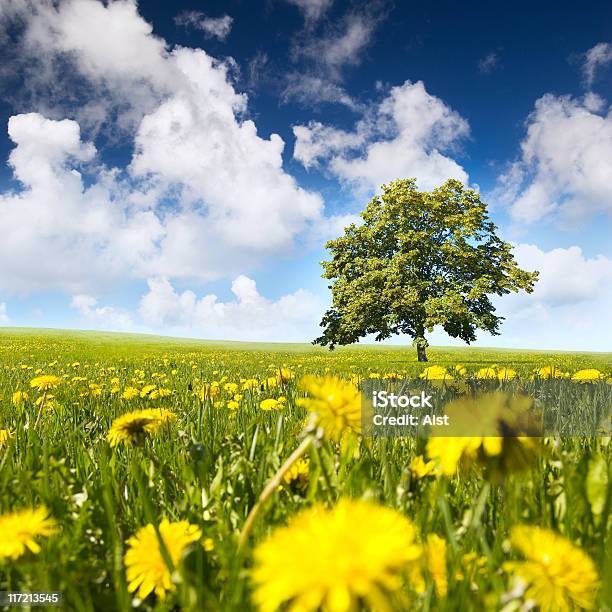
[504,525,599,612]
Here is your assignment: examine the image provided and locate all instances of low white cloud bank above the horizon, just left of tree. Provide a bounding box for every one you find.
[139,275,324,341]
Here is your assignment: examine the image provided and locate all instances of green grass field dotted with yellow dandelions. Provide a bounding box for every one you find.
[0,328,612,612]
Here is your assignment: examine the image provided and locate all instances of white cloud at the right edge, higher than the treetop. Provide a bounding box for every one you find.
[495,94,612,223]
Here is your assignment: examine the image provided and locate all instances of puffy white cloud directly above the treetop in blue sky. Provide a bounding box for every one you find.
[293,81,469,190]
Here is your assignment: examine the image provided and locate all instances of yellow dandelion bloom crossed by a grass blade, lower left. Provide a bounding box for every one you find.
[124,519,202,599]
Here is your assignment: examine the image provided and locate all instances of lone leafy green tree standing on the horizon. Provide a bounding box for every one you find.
[314,179,538,361]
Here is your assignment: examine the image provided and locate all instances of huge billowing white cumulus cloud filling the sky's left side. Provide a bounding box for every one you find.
[0,0,324,294]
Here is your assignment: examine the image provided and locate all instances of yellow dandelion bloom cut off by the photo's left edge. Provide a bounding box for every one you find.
[0,506,57,560]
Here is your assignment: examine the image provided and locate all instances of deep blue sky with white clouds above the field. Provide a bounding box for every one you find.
[0,0,612,350]
